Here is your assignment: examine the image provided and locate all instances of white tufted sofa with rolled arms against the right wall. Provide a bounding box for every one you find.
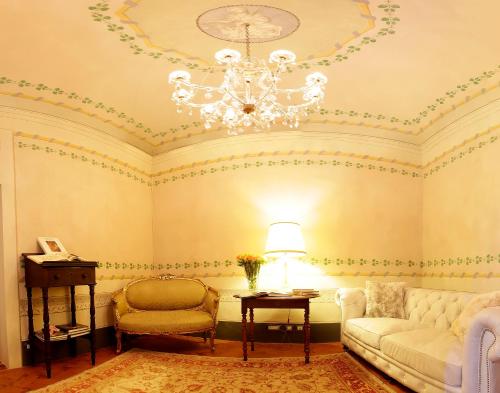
[336,288,500,393]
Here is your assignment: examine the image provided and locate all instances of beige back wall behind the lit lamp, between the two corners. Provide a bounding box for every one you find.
[153,132,421,322]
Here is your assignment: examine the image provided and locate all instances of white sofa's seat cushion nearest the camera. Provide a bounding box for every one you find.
[380,328,463,386]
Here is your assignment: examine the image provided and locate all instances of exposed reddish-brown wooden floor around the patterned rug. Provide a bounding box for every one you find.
[0,336,412,393]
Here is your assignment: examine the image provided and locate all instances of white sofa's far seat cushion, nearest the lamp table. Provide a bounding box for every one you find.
[345,318,420,349]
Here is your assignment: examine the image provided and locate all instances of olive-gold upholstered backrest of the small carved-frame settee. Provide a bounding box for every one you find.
[125,278,207,311]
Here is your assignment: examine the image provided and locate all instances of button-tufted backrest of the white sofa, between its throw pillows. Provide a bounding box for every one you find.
[404,288,474,330]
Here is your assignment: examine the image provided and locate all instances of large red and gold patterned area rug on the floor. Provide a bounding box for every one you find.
[36,349,394,393]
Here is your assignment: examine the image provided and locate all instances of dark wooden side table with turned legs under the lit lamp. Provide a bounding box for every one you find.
[237,296,311,364]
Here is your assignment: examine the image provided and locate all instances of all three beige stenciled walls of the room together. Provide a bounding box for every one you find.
[0,101,500,364]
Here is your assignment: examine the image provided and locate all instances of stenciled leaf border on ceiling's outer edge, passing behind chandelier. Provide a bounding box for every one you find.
[0,65,500,142]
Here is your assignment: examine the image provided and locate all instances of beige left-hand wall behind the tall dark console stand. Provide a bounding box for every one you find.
[1,108,154,364]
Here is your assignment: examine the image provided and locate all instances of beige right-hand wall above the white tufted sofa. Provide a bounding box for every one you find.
[422,101,500,292]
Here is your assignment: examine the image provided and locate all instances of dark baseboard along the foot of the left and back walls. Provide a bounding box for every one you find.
[22,321,340,366]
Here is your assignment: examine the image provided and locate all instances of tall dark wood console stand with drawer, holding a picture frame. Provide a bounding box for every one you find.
[23,254,97,378]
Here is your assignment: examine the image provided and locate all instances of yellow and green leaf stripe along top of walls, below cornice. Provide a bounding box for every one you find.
[15,124,500,186]
